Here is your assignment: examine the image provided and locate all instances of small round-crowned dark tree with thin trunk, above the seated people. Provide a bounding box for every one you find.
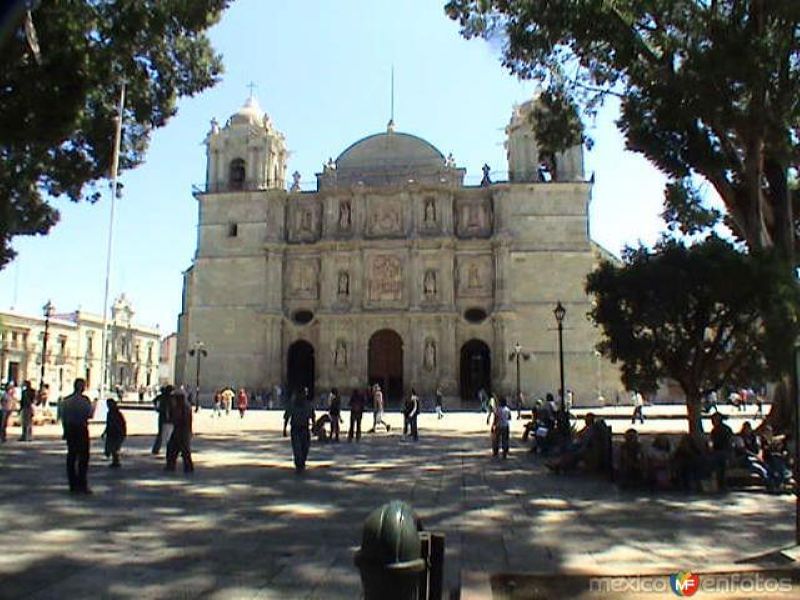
[586,236,800,434]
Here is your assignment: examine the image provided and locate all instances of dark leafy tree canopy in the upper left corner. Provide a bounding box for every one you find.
[0,0,230,268]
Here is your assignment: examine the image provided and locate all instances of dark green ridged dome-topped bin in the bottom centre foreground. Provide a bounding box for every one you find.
[355,500,425,600]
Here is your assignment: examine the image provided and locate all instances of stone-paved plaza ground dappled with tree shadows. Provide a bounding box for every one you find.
[0,411,794,599]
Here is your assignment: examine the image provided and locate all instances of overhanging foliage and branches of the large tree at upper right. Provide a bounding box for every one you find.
[445,0,800,261]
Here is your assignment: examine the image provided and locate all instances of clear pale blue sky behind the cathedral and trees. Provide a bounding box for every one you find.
[0,0,665,335]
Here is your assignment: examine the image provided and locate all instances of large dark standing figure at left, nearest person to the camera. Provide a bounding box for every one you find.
[61,378,94,494]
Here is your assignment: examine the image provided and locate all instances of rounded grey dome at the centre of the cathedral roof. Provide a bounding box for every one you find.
[336,131,445,173]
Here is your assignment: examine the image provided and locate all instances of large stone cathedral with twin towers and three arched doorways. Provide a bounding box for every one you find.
[176,96,620,403]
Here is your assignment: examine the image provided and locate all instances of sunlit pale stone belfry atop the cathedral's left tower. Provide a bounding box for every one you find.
[205,94,287,193]
